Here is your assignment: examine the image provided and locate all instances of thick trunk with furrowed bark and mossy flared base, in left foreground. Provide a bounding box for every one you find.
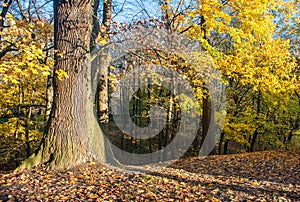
[19,0,112,169]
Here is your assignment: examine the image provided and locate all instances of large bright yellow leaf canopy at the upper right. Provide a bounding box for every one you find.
[172,0,299,93]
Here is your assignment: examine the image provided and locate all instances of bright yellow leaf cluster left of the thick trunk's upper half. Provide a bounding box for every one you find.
[0,14,53,84]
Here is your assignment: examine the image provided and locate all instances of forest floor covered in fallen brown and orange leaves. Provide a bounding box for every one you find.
[0,151,300,201]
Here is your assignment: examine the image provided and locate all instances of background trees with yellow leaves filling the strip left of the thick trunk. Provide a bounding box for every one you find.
[0,2,53,169]
